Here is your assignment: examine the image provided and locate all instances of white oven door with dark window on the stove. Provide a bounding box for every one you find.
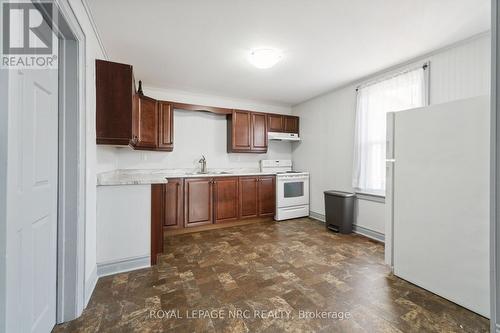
[276,176,309,207]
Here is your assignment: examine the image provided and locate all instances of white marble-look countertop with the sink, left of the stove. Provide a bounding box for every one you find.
[97,168,275,186]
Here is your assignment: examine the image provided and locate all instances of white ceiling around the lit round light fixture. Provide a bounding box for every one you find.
[87,0,490,105]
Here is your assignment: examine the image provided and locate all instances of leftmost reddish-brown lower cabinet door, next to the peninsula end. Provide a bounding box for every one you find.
[163,178,184,229]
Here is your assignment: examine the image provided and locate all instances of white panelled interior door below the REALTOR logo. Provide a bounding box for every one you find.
[7,65,58,332]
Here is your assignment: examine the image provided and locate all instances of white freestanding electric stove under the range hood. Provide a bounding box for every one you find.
[260,160,309,221]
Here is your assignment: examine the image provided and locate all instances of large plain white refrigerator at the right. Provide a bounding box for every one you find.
[385,96,490,317]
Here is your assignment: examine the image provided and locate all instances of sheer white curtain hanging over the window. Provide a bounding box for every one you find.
[352,67,426,195]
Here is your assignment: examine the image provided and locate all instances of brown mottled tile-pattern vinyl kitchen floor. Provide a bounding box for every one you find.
[54,218,489,333]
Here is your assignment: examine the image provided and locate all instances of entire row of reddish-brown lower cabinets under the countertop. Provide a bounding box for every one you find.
[151,176,276,265]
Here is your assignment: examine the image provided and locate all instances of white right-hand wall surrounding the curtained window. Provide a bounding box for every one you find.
[292,34,490,236]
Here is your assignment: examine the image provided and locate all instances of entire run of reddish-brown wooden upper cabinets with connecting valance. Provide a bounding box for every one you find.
[96,60,299,153]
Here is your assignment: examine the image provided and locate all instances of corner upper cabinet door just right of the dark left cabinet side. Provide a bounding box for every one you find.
[132,96,158,149]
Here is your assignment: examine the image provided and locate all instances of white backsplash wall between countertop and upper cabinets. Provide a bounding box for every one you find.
[97,110,296,172]
